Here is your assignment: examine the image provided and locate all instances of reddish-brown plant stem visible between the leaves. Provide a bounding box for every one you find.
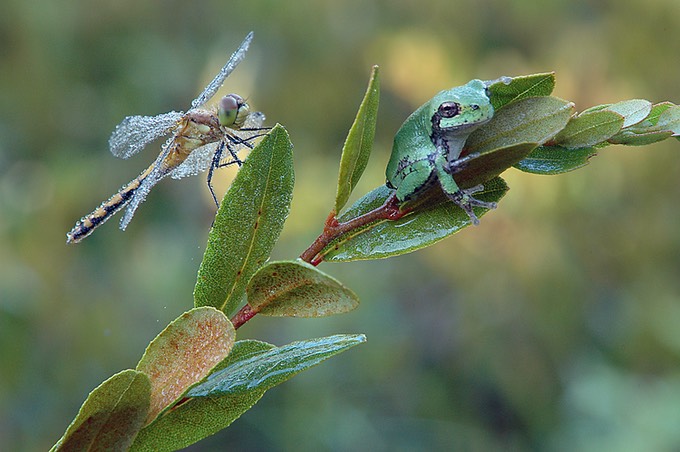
[231,193,410,329]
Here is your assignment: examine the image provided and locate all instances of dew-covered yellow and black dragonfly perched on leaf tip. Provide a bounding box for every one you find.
[66,32,269,243]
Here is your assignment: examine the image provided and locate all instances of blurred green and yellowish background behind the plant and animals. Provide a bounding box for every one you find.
[0,0,680,451]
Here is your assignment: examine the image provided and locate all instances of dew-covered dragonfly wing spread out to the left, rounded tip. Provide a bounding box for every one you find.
[109,111,184,159]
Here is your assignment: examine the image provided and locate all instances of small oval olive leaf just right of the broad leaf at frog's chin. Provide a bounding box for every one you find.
[554,110,624,149]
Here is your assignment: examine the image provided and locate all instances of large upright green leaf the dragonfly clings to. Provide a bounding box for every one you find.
[194,125,295,315]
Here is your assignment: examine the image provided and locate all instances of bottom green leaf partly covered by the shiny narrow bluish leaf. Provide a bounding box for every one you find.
[131,340,274,452]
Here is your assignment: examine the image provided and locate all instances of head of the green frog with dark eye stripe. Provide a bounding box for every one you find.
[430,80,493,133]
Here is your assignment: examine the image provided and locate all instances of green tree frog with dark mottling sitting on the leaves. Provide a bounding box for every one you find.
[386,80,495,215]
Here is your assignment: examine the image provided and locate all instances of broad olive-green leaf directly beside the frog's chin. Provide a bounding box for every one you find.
[465,97,573,154]
